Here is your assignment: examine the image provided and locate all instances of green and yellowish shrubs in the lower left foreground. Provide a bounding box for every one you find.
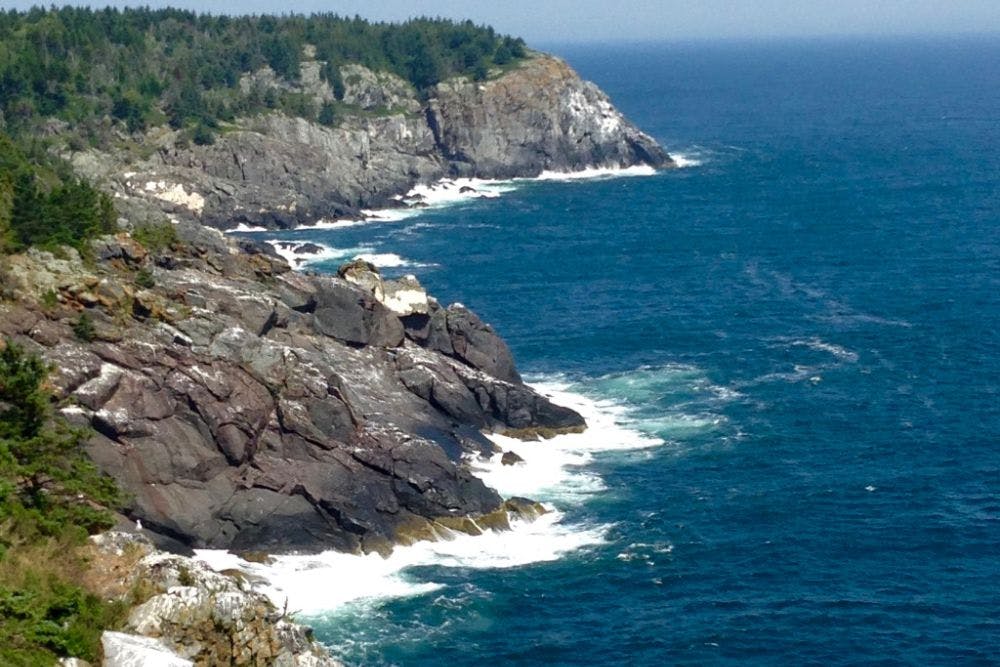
[0,341,124,665]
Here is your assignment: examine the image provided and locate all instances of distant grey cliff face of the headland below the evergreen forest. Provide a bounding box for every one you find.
[74,55,673,229]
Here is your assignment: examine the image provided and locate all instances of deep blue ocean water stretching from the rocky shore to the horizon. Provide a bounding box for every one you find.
[252,38,1000,667]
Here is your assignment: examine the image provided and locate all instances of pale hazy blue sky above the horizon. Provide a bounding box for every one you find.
[7,0,1000,44]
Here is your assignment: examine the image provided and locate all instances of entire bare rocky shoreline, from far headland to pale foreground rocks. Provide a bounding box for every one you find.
[0,44,675,667]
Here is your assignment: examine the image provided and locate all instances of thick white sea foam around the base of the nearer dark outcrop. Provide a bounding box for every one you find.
[198,382,663,618]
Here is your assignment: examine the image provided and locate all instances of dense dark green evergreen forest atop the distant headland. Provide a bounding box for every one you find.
[0,7,525,145]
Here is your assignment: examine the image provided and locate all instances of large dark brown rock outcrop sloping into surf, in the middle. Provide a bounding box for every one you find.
[0,225,584,552]
